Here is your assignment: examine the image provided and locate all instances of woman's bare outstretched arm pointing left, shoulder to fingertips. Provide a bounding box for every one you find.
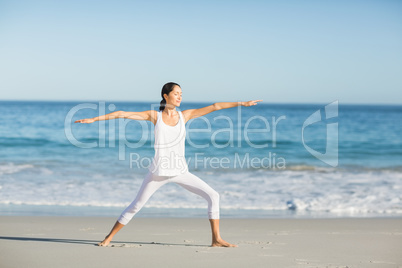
[74,110,156,124]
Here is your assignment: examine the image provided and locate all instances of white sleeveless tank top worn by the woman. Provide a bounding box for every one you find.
[149,111,188,176]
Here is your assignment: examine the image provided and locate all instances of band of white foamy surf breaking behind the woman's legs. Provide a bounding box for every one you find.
[0,165,402,215]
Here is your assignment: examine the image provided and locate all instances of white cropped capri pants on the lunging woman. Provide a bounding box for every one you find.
[118,171,219,225]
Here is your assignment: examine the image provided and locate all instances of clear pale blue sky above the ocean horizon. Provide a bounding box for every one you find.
[0,0,402,104]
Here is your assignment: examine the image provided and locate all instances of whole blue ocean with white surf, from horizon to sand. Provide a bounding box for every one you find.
[0,101,402,218]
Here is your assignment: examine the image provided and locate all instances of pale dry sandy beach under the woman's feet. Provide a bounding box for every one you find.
[0,216,402,268]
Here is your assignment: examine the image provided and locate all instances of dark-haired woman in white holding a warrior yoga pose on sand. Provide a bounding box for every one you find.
[75,82,261,247]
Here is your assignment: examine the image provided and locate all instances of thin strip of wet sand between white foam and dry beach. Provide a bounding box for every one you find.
[0,204,402,219]
